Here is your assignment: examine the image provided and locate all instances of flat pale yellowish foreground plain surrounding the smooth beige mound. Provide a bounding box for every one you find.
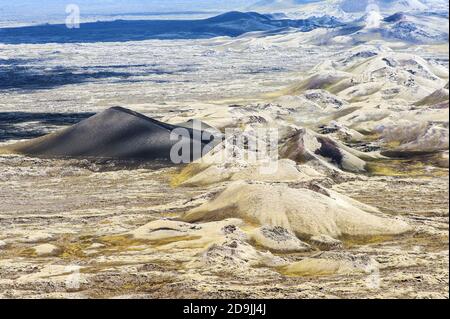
[0,157,449,298]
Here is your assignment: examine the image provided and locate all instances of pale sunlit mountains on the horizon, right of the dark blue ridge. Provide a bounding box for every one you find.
[232,11,449,47]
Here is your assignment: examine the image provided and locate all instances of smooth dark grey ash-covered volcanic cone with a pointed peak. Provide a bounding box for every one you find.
[8,107,216,161]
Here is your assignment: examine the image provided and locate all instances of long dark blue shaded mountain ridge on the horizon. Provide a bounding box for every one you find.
[0,11,342,44]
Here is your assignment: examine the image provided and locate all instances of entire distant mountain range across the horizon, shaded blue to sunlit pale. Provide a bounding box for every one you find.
[0,11,449,44]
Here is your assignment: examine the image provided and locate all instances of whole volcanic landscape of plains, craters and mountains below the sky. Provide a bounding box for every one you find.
[0,5,449,298]
